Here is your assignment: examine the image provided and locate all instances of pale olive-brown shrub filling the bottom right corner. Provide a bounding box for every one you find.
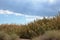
[32,30,60,40]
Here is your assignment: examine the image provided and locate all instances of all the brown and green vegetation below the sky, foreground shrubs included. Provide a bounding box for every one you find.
[0,15,60,40]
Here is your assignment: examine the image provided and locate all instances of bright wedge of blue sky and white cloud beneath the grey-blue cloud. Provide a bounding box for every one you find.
[0,10,52,24]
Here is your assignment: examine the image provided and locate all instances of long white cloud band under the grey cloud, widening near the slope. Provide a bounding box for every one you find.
[0,10,53,22]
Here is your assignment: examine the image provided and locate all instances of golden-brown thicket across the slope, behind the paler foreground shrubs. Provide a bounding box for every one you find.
[0,16,60,39]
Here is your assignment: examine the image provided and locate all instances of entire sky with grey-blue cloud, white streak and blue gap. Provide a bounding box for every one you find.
[0,0,60,24]
